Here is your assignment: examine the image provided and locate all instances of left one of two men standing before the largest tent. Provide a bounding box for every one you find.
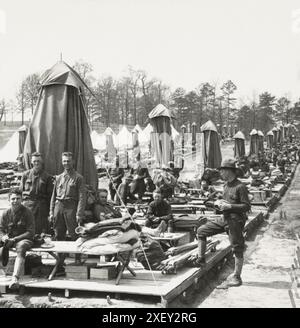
[21,152,53,234]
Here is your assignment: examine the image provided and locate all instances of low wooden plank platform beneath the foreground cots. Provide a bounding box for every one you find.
[0,209,267,307]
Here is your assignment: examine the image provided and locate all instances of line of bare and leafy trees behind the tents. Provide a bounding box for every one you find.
[0,60,300,137]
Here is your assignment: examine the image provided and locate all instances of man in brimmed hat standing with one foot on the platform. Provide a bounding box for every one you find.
[189,158,251,288]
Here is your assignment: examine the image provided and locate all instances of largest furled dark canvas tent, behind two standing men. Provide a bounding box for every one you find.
[24,61,98,188]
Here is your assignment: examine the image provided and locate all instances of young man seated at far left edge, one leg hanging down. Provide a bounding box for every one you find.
[0,188,35,288]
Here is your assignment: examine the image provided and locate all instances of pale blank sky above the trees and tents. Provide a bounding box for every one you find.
[0,0,300,100]
